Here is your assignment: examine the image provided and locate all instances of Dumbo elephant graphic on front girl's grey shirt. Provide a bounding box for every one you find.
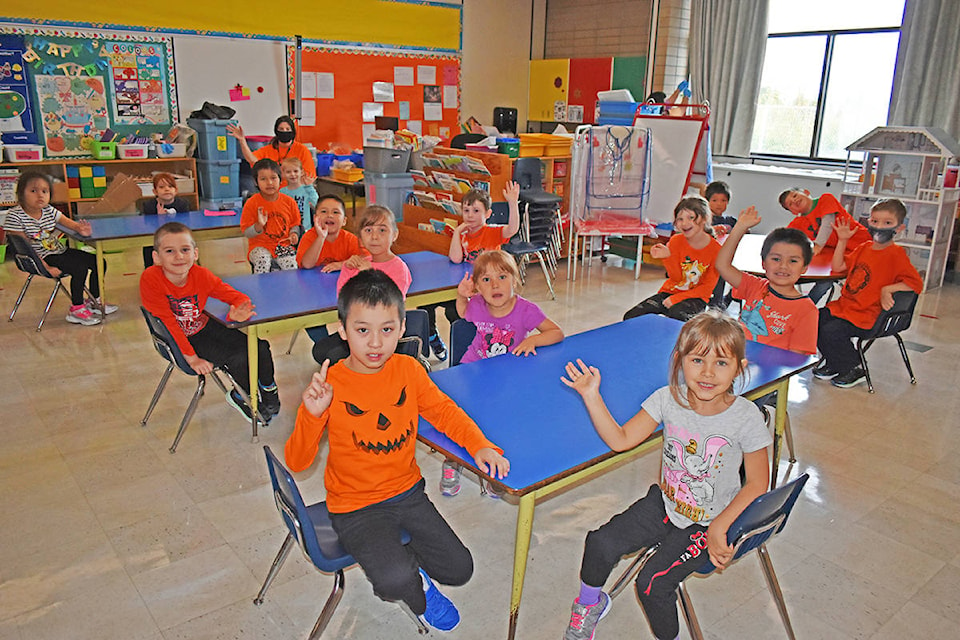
[661,426,731,522]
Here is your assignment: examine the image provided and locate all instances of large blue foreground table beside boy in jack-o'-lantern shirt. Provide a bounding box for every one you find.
[418,315,816,638]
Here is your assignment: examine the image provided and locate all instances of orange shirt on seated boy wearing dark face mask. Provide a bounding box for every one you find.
[827,241,923,329]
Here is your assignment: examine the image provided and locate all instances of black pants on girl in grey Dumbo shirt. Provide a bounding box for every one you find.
[580,485,709,640]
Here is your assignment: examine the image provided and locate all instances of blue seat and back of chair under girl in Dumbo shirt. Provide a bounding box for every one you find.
[697,473,810,575]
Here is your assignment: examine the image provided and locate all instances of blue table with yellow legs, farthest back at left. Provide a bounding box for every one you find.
[64,211,240,308]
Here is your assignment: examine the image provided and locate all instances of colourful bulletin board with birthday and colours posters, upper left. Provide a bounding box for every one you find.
[0,27,177,157]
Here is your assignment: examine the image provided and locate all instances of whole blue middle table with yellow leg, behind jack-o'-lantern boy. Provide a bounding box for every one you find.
[205,251,472,442]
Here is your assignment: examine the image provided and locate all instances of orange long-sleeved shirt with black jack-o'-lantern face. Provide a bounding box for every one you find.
[285,354,502,513]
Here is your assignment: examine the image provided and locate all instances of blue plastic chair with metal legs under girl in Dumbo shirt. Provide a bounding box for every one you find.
[610,473,810,640]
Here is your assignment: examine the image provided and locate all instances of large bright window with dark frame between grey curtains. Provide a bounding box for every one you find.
[750,0,904,160]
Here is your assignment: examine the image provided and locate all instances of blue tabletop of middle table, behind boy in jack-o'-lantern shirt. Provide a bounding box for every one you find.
[206,251,471,327]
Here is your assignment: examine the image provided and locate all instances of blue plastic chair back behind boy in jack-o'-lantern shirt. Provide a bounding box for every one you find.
[263,446,356,573]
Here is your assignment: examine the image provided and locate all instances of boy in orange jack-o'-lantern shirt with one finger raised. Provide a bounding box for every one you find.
[285,269,510,631]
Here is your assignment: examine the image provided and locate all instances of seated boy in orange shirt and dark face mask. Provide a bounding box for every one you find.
[813,198,923,389]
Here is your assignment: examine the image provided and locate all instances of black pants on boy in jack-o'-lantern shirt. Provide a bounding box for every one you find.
[330,478,473,615]
